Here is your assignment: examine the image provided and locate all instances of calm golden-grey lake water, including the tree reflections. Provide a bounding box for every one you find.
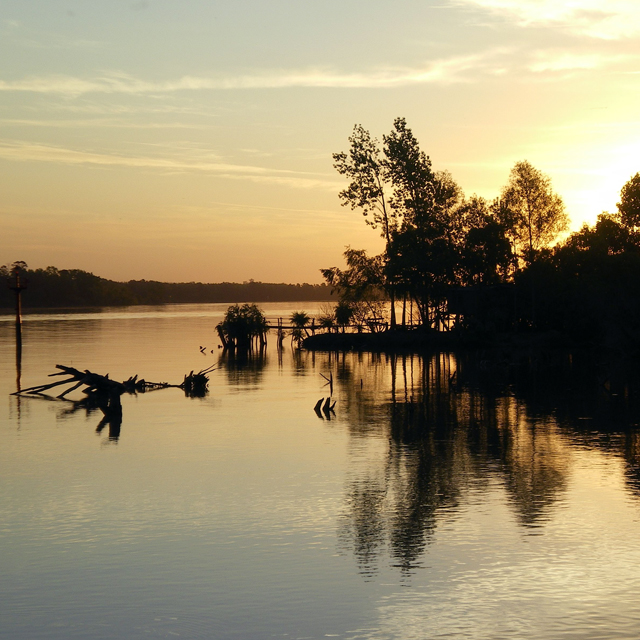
[0,303,640,640]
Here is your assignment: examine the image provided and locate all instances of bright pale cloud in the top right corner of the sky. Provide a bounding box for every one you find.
[451,0,640,40]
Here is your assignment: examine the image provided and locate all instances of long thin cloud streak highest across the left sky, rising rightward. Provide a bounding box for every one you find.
[0,50,505,96]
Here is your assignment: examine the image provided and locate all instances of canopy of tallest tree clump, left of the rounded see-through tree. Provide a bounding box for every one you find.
[330,118,524,327]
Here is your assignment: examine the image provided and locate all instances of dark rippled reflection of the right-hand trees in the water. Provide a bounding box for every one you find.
[333,353,640,576]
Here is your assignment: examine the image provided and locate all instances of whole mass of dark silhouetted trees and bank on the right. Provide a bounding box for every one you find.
[305,118,640,350]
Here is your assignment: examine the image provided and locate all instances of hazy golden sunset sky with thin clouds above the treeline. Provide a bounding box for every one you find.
[0,0,640,282]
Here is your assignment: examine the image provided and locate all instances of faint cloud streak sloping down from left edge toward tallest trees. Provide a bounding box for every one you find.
[0,141,341,191]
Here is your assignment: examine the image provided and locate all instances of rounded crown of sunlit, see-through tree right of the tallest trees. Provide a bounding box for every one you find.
[496,160,569,262]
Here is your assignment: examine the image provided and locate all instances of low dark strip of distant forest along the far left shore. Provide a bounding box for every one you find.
[0,262,331,311]
